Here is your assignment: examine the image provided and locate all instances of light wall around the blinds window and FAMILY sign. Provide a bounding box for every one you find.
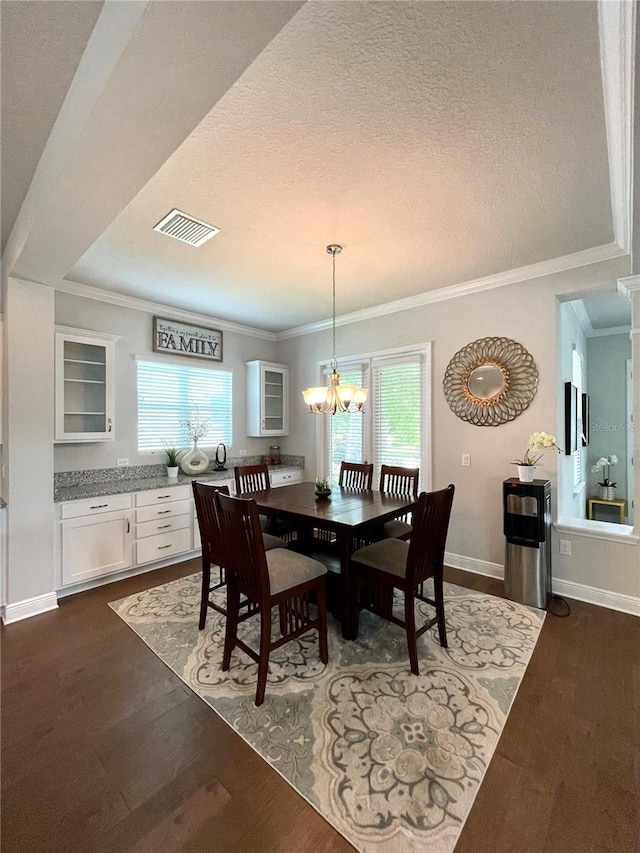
[54,293,284,471]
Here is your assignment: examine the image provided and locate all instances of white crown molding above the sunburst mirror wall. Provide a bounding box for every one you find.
[276,243,628,341]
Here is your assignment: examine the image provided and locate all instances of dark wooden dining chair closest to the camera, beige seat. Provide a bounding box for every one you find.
[215,493,329,705]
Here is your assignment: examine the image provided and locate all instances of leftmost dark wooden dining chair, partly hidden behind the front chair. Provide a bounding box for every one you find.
[191,480,286,631]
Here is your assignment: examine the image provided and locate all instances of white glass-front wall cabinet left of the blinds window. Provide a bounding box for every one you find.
[55,326,118,442]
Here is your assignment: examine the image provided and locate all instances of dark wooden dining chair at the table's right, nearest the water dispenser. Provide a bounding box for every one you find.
[351,485,455,675]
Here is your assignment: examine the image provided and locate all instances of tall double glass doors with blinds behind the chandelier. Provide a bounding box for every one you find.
[319,351,428,487]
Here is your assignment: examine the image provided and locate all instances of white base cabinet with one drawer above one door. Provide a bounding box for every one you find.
[62,495,133,584]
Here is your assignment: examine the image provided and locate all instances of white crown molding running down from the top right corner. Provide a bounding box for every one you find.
[598,0,636,252]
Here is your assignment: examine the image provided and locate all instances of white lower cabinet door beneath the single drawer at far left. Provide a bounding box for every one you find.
[62,510,132,584]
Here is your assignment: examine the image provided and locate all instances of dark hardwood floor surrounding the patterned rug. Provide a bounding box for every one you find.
[1,560,640,853]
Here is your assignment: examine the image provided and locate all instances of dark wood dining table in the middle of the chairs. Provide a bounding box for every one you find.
[238,482,416,639]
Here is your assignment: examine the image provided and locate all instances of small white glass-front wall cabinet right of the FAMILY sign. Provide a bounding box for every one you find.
[247,361,289,436]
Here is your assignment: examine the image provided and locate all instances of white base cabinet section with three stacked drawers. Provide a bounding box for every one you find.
[135,486,193,565]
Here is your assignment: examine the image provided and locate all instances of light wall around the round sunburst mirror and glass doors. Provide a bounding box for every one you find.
[277,258,640,598]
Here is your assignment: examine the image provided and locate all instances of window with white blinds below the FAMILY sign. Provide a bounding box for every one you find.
[137,360,233,453]
